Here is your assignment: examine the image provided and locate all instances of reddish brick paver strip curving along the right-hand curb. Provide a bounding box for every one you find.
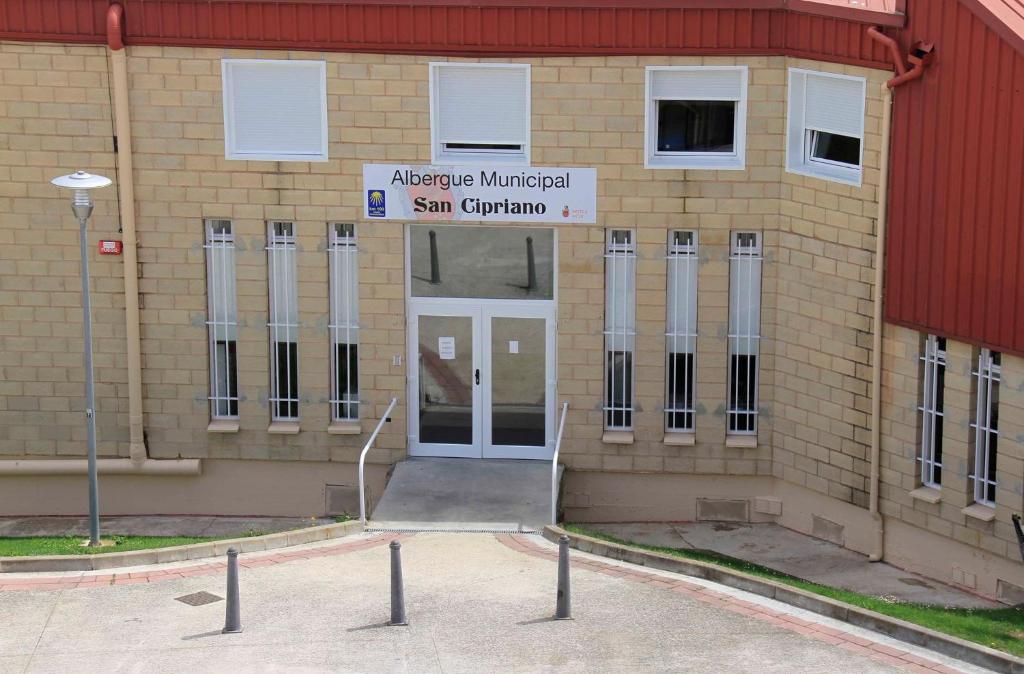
[495,534,958,674]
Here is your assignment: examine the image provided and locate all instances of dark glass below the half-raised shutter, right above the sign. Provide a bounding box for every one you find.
[657,100,736,153]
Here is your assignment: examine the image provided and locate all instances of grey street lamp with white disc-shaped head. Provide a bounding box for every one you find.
[50,171,111,547]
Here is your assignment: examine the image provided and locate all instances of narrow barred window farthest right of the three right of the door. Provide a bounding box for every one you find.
[726,231,764,435]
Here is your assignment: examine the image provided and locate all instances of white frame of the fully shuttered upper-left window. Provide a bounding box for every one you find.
[220,58,329,162]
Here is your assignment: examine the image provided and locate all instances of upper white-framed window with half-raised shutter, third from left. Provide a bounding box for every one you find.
[644,66,746,169]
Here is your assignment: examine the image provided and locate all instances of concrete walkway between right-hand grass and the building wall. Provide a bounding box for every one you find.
[584,522,1005,608]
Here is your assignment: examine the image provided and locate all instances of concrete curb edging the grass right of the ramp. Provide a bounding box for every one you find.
[543,526,1024,674]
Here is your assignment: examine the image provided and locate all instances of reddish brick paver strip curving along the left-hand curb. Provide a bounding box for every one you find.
[0,534,412,592]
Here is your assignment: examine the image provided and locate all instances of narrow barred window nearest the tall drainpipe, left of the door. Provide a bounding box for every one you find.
[203,220,239,419]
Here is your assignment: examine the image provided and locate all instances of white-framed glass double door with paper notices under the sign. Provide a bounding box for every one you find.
[409,300,555,459]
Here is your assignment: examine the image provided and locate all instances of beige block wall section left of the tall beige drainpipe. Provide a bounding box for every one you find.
[0,43,128,457]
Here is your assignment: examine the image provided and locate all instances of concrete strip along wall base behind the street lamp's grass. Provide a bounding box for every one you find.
[0,515,334,538]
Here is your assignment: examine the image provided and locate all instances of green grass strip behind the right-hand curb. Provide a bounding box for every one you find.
[565,524,1024,656]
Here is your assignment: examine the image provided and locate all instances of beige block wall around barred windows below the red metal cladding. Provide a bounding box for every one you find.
[881,325,1024,569]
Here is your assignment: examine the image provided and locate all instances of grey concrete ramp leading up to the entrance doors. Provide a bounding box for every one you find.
[368,458,561,532]
